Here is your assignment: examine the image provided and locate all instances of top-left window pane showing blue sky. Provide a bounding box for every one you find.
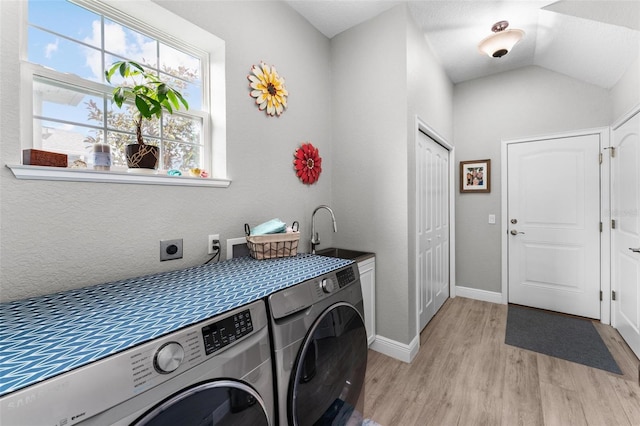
[28,0,101,48]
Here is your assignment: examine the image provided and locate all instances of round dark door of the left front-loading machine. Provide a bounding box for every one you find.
[132,380,269,426]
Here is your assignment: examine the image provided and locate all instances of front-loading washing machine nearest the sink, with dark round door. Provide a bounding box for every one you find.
[267,263,368,426]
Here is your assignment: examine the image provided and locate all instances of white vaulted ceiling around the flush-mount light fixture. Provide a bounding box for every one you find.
[286,0,640,89]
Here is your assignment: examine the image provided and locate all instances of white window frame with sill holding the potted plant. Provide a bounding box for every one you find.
[8,0,231,187]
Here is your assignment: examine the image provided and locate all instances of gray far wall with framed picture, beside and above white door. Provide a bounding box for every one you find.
[453,66,611,293]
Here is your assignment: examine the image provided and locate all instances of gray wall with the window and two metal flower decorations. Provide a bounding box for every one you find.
[0,1,336,301]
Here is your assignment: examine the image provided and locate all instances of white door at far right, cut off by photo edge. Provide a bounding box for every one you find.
[611,113,640,357]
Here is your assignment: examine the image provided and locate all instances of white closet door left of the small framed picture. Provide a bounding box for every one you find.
[416,128,449,331]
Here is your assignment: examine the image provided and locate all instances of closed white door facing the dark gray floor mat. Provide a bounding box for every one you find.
[507,134,600,319]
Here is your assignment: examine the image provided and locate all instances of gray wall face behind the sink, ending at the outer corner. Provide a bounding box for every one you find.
[331,7,408,342]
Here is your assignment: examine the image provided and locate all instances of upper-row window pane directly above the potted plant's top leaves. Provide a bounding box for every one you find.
[104,19,158,68]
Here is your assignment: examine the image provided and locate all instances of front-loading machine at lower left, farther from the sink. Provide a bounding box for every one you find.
[0,300,274,426]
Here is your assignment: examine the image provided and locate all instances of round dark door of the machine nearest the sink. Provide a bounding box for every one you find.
[289,303,368,426]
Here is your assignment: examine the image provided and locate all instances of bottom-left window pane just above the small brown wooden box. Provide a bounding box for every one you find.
[33,119,98,161]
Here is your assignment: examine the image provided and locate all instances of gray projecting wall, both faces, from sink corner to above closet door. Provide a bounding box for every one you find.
[331,5,453,344]
